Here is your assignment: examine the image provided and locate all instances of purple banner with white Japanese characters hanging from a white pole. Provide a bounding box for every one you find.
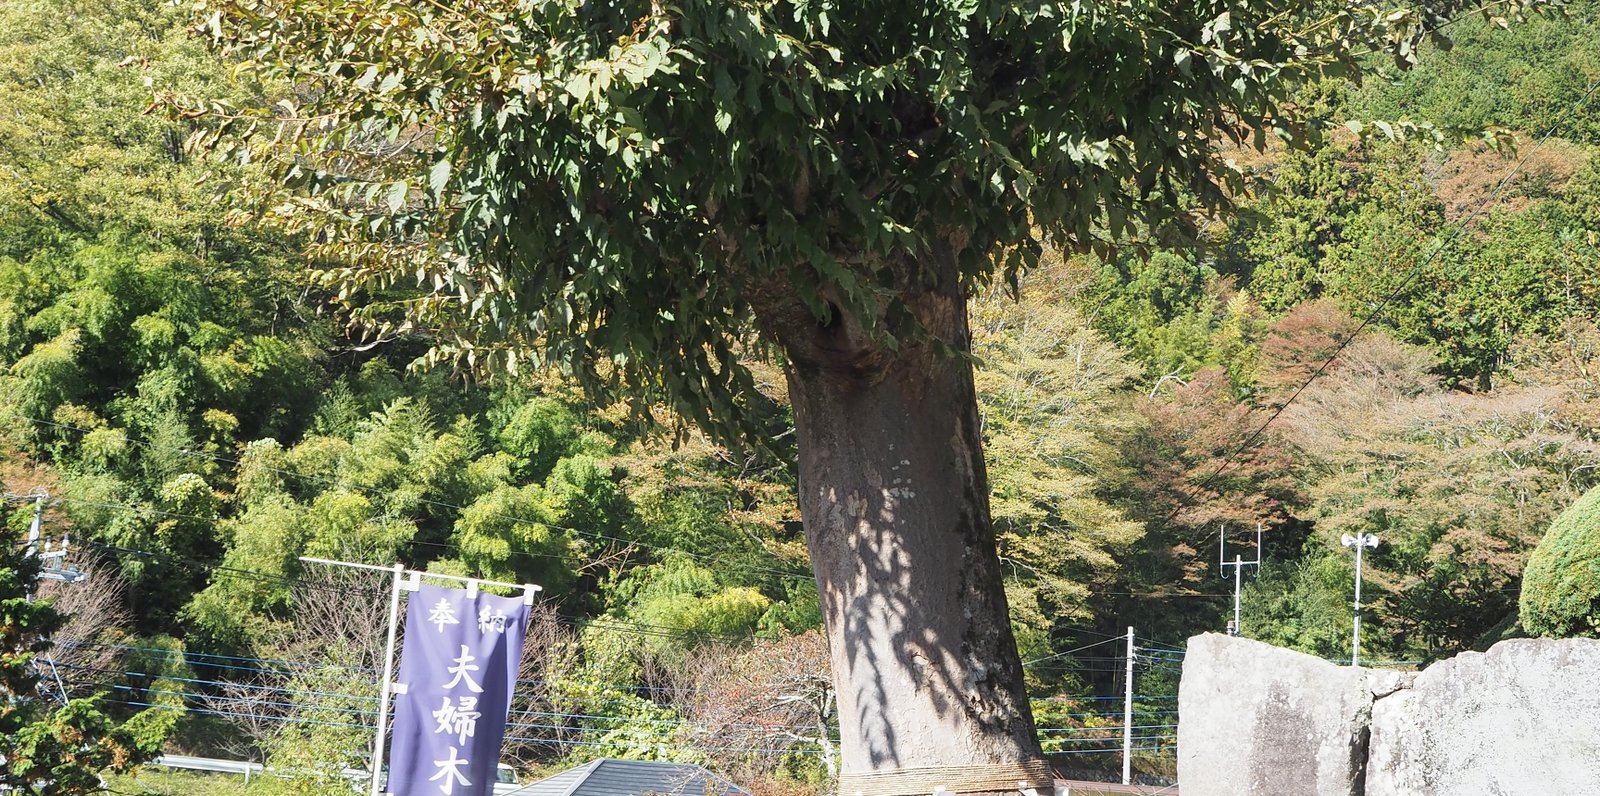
[384,587,528,796]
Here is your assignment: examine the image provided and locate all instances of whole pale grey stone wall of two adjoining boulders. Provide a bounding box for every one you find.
[1178,633,1600,796]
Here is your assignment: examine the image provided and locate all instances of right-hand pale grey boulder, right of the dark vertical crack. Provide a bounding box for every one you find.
[1363,638,1600,796]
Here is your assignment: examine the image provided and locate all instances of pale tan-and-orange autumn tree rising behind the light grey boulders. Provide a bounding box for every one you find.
[1285,326,1597,655]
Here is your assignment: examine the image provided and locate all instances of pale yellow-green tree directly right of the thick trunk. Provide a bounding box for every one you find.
[973,258,1144,677]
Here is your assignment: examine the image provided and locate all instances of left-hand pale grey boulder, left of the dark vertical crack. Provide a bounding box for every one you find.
[1178,633,1410,796]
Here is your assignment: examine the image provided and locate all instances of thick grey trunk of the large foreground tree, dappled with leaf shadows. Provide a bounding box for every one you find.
[755,246,1042,794]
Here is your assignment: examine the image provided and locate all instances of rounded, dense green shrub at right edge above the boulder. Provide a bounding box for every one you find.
[1520,488,1600,638]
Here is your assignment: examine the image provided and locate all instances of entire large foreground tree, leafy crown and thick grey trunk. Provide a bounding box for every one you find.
[174,0,1531,793]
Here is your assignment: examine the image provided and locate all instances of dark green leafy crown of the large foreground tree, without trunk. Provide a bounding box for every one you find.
[187,0,1510,441]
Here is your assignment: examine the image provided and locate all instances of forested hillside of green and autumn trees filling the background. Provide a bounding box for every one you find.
[0,0,1600,793]
